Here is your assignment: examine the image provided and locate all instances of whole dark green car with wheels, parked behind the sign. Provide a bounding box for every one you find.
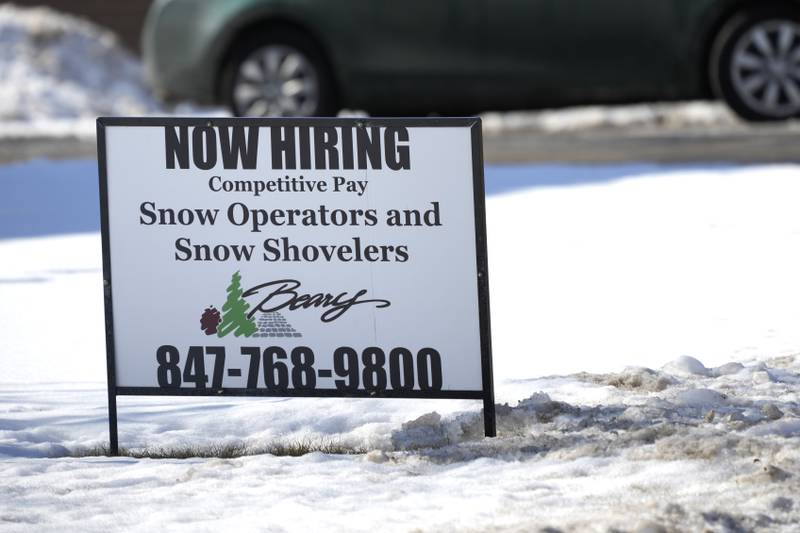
[143,0,800,120]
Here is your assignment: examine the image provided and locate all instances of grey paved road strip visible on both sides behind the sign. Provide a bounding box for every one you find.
[0,126,800,164]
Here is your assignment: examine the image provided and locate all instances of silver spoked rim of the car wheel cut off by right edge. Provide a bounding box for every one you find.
[730,20,800,118]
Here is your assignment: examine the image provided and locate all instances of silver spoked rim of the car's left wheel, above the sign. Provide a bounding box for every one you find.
[233,44,319,117]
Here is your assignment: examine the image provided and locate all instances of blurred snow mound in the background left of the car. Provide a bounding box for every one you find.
[0,4,161,127]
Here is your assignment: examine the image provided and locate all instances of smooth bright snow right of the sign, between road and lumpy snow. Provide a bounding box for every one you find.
[487,165,800,377]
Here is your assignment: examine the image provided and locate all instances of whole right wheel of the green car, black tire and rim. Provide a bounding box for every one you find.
[709,6,800,121]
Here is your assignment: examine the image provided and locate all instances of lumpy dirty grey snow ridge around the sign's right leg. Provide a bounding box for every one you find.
[384,356,800,456]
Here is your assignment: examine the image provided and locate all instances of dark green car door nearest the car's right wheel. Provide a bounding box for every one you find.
[486,0,676,105]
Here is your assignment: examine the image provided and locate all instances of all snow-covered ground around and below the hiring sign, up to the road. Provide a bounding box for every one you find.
[0,165,800,532]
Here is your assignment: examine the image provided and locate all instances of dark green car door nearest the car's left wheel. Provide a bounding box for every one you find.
[348,0,485,111]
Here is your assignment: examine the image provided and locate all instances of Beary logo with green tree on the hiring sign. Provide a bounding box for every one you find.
[200,271,391,337]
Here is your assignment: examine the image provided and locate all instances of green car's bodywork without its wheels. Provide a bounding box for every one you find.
[143,0,797,114]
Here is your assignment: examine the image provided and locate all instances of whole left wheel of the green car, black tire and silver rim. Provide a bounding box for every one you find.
[220,30,338,117]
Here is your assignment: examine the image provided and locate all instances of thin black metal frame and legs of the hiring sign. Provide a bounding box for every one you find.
[97,117,496,455]
